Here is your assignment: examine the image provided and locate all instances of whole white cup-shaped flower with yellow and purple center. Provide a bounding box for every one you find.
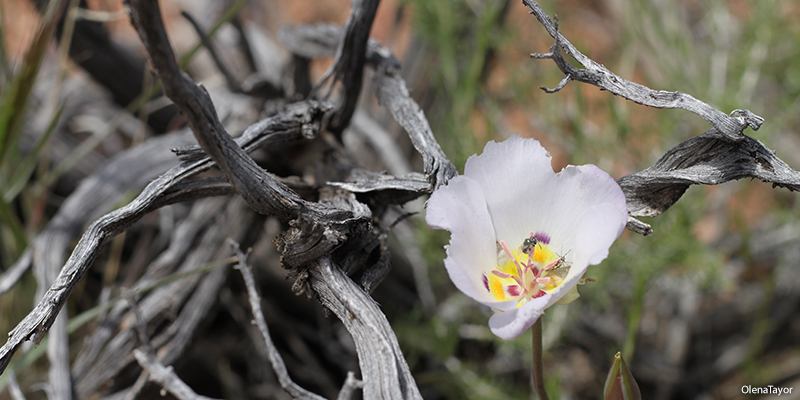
[425,135,628,339]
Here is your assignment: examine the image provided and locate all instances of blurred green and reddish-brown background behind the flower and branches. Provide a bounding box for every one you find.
[0,0,800,400]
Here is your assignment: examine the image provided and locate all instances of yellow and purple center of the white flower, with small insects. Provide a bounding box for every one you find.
[483,233,569,307]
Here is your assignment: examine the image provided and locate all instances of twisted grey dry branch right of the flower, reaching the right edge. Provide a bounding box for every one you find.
[523,0,800,235]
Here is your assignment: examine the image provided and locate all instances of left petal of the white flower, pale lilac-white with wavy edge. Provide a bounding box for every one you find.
[425,176,497,304]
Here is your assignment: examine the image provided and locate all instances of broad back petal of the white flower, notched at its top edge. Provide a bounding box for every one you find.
[464,135,627,263]
